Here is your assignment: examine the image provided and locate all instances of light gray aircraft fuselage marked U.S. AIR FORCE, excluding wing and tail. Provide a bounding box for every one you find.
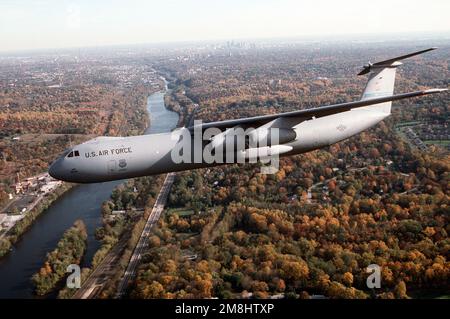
[49,109,389,183]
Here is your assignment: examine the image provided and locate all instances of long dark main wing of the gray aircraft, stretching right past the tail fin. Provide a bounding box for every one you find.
[188,89,447,132]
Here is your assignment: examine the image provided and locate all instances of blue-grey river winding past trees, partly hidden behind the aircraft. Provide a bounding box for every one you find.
[0,83,178,298]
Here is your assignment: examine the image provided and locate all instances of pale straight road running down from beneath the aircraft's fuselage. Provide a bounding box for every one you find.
[116,173,175,298]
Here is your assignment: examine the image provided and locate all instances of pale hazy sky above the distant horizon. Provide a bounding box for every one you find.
[0,0,450,51]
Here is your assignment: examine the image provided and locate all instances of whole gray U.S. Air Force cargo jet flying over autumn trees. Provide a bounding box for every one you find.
[49,48,447,183]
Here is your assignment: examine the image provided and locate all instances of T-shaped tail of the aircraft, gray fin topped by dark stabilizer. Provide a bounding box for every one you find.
[358,47,437,114]
